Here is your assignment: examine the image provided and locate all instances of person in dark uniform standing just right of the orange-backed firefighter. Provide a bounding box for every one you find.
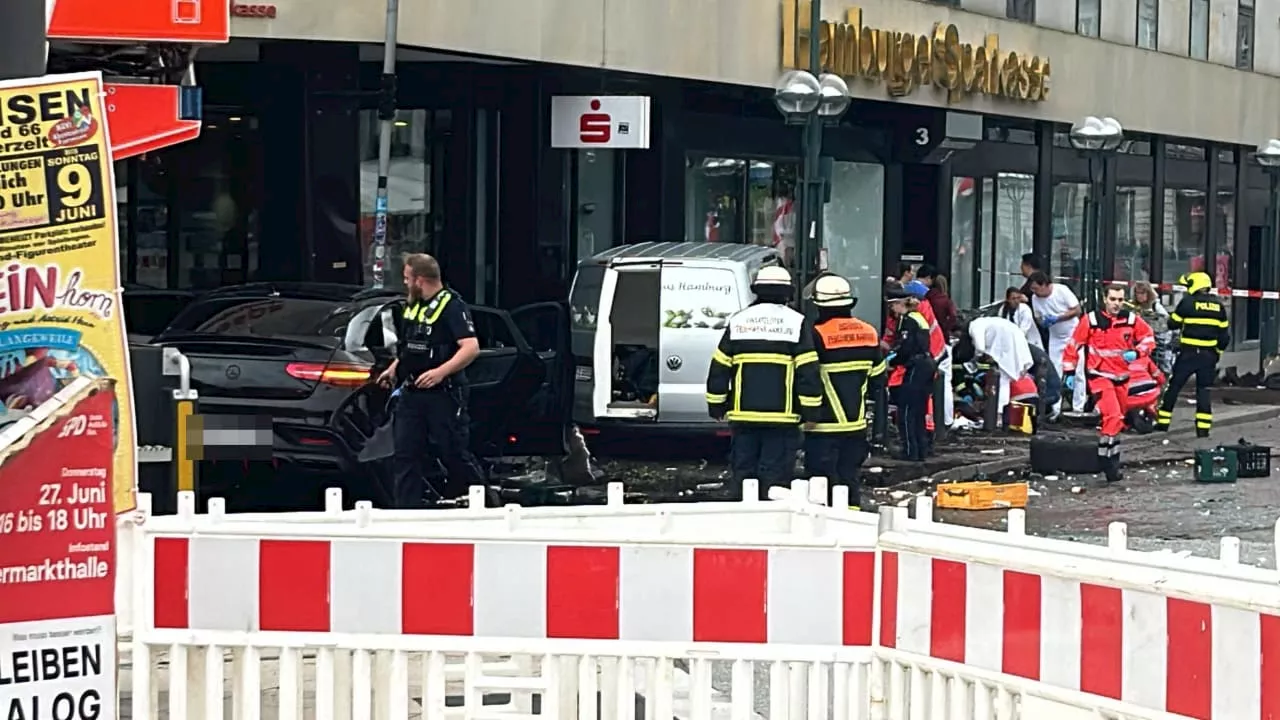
[884,288,938,461]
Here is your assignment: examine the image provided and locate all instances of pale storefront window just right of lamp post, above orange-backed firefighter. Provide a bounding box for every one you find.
[823,163,884,327]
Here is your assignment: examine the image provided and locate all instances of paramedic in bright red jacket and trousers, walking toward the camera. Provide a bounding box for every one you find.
[1062,286,1156,482]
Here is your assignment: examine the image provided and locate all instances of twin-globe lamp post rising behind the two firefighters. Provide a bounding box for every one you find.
[773,30,850,292]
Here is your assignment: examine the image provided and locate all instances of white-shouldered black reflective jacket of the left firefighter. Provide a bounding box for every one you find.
[707,302,822,425]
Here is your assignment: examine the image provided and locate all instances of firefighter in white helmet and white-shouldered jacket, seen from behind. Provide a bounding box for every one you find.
[707,265,822,495]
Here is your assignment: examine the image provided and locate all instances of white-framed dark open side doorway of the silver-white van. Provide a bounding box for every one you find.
[591,259,662,420]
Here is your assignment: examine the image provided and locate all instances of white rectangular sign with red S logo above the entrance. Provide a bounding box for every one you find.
[552,95,650,150]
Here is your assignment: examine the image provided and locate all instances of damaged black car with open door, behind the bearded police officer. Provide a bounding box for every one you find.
[141,283,573,497]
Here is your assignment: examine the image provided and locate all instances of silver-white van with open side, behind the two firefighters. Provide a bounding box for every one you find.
[570,242,781,432]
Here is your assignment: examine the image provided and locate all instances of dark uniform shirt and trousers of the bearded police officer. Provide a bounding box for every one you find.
[393,288,484,509]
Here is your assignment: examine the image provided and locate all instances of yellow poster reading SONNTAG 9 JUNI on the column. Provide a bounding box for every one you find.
[0,73,137,512]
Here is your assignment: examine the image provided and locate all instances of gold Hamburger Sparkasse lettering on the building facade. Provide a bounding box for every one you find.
[782,0,1051,102]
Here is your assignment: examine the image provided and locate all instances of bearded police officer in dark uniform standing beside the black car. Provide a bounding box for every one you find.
[379,252,484,510]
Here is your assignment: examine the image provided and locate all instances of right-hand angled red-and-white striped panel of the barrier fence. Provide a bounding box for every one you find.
[878,502,1280,720]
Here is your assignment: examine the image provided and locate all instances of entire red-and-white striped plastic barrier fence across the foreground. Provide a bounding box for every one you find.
[112,482,1280,720]
